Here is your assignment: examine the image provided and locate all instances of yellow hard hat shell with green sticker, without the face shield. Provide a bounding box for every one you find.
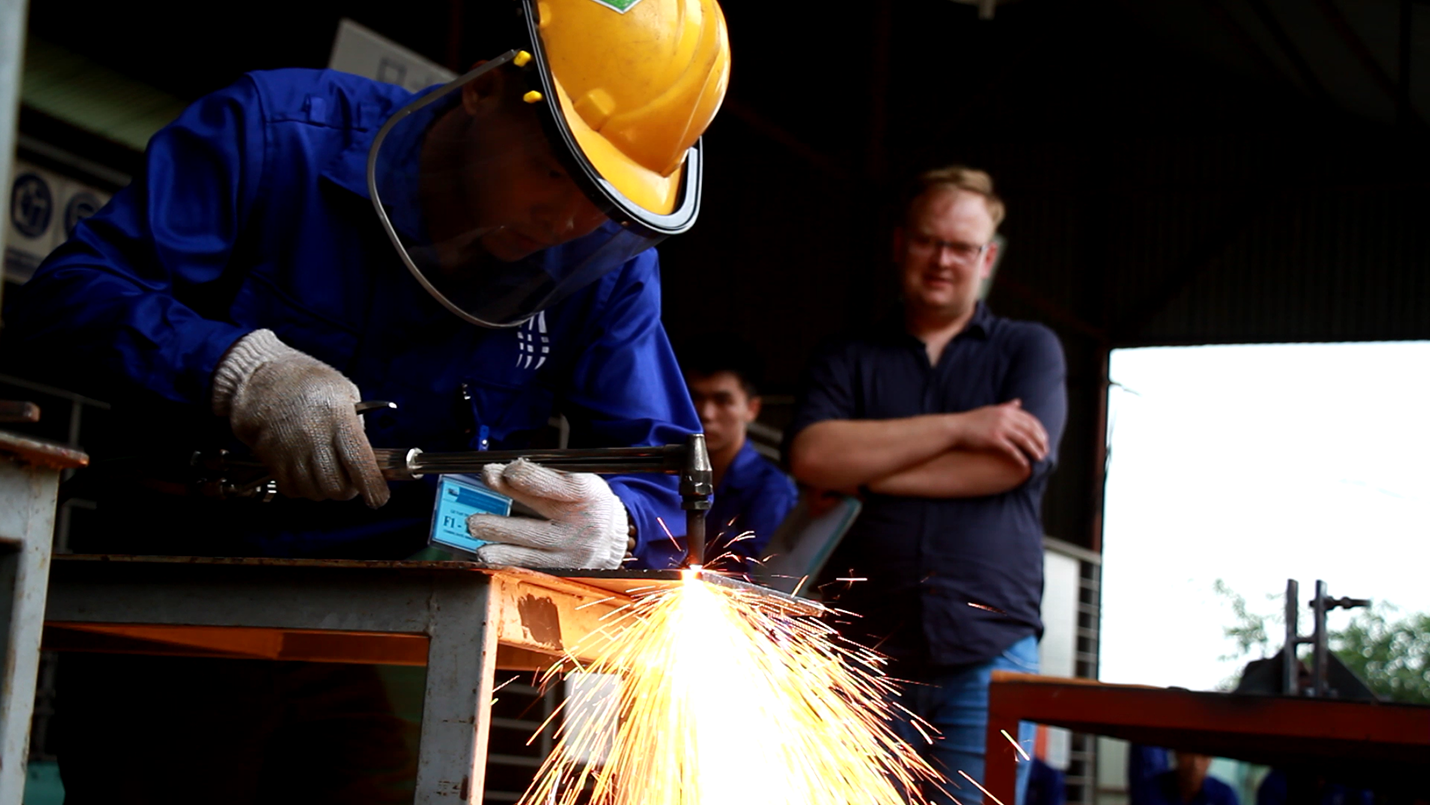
[523,0,729,234]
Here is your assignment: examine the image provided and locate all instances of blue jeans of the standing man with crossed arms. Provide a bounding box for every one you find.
[892,635,1038,805]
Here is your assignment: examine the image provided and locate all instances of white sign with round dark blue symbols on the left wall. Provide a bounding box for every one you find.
[4,159,109,282]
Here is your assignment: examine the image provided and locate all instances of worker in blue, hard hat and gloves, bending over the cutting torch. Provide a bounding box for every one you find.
[7,0,729,804]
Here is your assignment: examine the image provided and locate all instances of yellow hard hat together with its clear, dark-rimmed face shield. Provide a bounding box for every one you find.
[368,0,729,327]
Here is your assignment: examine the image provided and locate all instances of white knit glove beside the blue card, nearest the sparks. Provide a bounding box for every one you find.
[466,459,629,571]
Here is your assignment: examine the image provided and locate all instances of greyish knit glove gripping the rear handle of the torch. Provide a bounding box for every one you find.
[213,330,389,509]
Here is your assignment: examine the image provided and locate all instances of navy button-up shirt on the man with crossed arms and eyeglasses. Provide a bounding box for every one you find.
[788,303,1067,672]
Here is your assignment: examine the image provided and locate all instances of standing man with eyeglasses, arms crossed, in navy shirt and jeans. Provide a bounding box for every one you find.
[787,166,1067,804]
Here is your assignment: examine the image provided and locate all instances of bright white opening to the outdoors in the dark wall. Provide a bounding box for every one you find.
[1101,342,1430,691]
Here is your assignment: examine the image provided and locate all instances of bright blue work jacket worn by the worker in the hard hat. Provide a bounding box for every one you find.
[7,70,699,558]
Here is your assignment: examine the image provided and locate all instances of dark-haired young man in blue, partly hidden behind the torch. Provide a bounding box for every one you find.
[678,335,799,572]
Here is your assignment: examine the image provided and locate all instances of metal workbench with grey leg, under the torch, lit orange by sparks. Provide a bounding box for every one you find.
[44,556,808,805]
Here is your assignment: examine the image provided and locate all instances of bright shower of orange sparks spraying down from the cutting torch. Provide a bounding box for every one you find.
[522,571,941,805]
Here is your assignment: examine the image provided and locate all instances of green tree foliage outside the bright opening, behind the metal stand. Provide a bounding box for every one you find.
[1213,579,1430,705]
